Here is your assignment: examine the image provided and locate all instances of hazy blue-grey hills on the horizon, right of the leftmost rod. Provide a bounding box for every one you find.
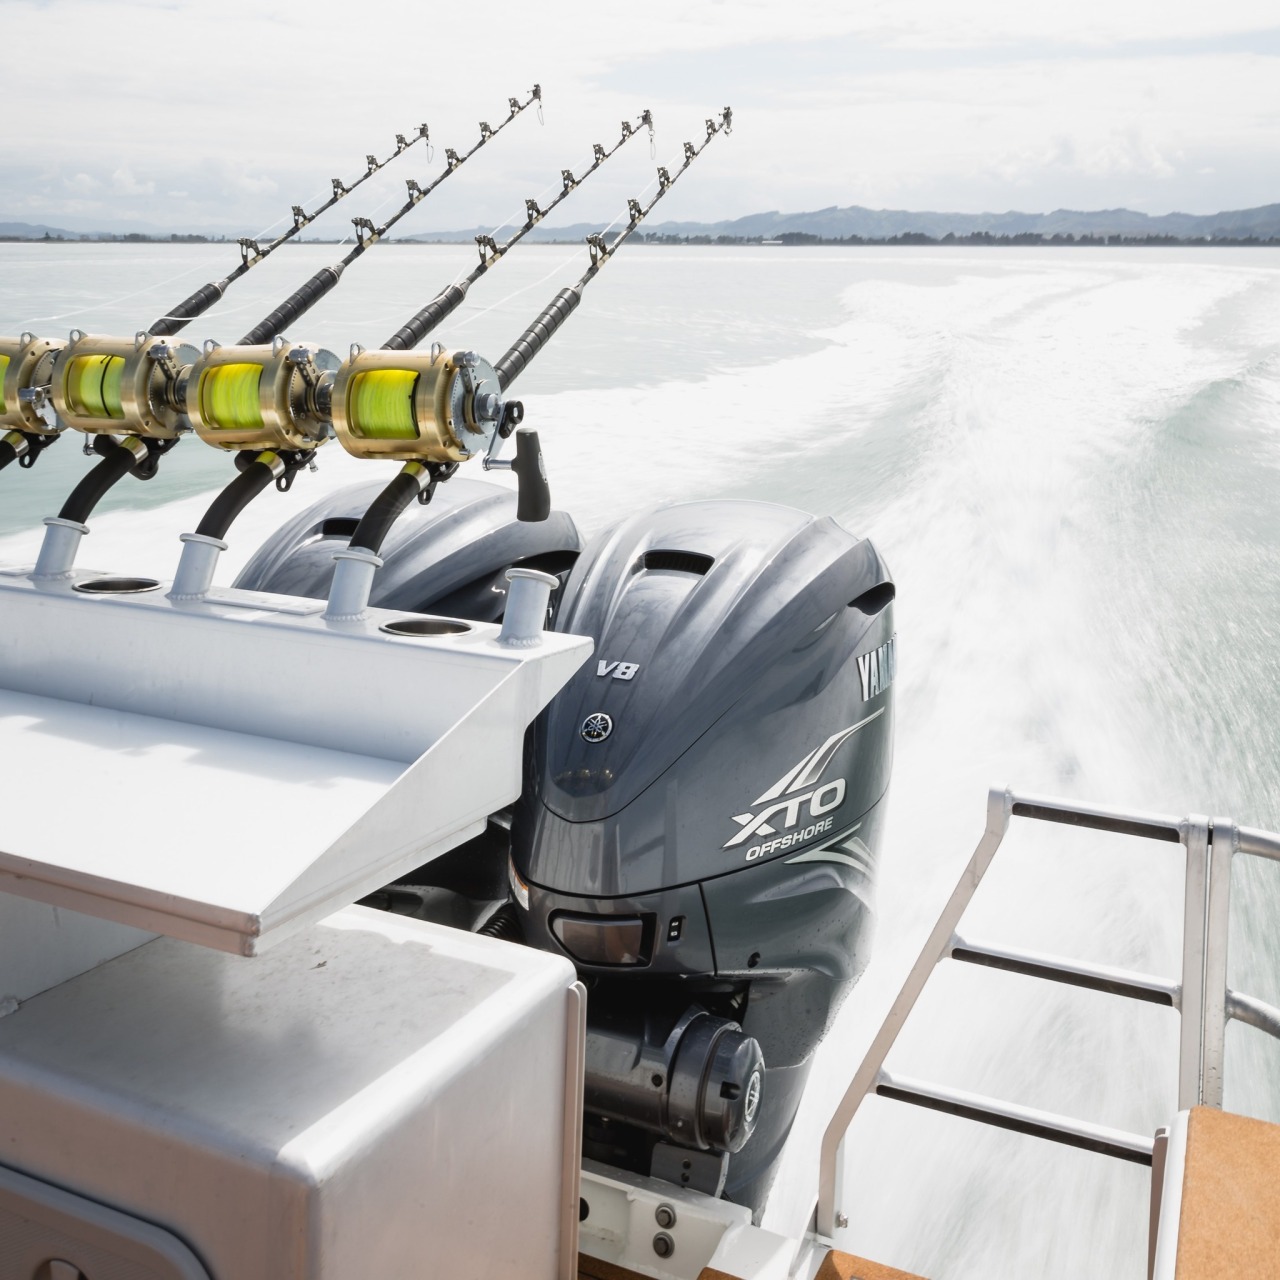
[411,205,1280,243]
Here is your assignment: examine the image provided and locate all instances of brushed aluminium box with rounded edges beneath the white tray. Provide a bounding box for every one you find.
[0,908,581,1280]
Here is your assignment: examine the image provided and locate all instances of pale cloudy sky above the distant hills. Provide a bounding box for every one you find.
[0,0,1280,238]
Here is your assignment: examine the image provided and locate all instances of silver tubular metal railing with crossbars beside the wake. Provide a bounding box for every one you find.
[814,788,1280,1238]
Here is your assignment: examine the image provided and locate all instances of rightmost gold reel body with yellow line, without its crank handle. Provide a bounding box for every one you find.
[333,346,503,463]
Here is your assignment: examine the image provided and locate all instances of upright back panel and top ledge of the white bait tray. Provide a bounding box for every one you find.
[0,575,589,764]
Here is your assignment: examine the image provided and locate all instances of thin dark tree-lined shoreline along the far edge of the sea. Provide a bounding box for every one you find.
[0,232,1280,248]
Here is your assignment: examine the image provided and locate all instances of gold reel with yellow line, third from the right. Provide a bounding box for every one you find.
[52,329,200,440]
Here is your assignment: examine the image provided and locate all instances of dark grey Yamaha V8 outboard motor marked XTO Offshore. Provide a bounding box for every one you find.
[511,502,895,1210]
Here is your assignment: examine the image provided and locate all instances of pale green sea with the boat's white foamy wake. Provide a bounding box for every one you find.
[0,244,1280,1280]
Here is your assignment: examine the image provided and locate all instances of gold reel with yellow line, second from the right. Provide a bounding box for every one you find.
[187,338,339,451]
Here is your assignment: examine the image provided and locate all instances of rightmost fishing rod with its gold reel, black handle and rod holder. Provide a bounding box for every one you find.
[311,108,733,621]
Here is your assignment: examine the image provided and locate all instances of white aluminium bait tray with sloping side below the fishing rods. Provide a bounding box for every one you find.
[0,573,591,957]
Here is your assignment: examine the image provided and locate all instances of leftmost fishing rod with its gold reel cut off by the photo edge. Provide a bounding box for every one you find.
[0,124,430,471]
